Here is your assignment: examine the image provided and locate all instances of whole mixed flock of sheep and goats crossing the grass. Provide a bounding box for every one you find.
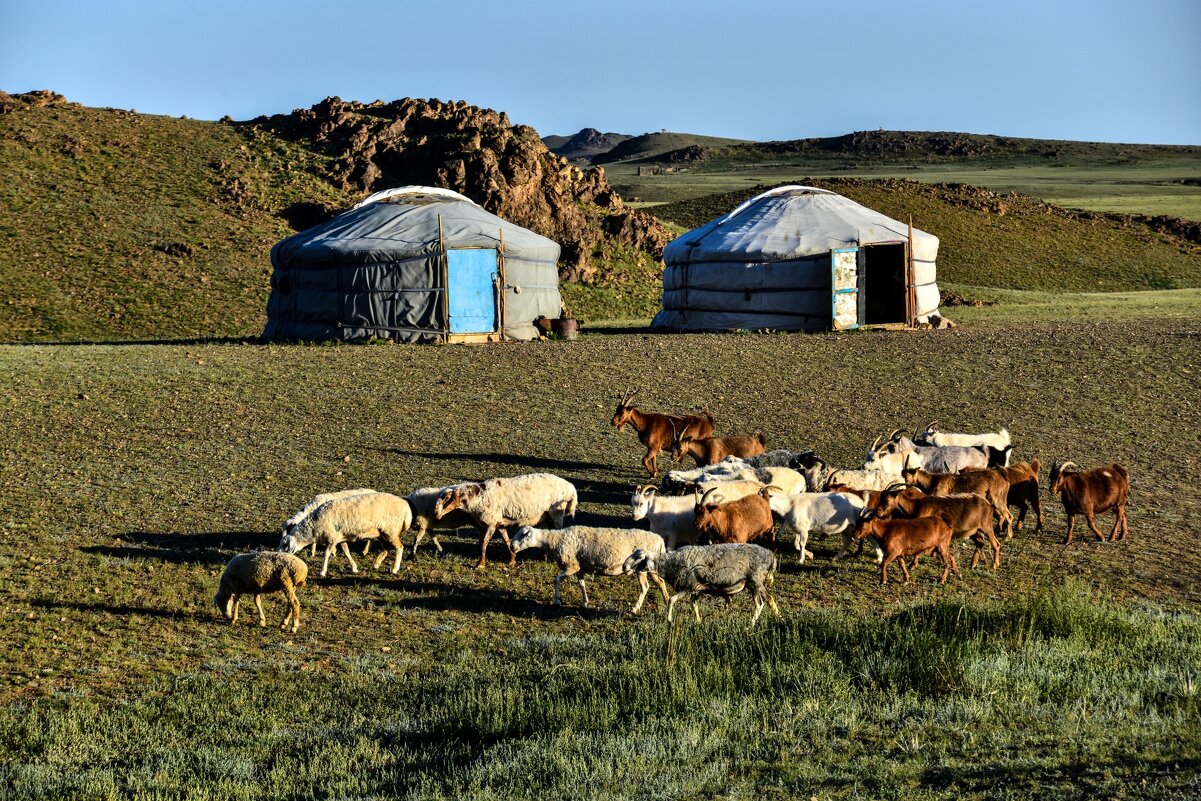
[214,391,1129,632]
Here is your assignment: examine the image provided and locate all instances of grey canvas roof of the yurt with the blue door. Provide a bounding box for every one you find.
[271,186,560,264]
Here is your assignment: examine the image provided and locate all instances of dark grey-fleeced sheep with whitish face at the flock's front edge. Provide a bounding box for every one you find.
[623,543,779,626]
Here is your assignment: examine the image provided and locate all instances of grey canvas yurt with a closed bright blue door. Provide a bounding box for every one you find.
[263,186,562,342]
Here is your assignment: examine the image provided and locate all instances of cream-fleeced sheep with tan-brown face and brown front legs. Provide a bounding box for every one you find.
[434,473,579,569]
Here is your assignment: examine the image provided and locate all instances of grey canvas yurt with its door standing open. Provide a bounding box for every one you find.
[653,186,938,331]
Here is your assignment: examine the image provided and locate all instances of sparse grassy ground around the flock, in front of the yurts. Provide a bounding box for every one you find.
[0,317,1201,799]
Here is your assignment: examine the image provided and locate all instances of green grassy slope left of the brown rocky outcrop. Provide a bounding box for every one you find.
[0,93,351,341]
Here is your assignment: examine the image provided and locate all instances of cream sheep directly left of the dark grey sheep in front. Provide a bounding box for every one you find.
[513,526,668,615]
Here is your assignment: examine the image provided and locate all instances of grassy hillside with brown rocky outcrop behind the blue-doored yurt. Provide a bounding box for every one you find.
[0,92,669,341]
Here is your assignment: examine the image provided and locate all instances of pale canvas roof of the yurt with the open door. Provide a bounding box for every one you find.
[663,185,938,264]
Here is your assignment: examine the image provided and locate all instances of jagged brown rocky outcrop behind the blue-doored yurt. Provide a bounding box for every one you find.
[249,97,670,282]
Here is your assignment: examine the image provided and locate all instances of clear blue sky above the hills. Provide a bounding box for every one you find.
[0,0,1201,144]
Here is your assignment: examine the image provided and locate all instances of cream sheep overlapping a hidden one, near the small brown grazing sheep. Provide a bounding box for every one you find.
[283,492,413,578]
